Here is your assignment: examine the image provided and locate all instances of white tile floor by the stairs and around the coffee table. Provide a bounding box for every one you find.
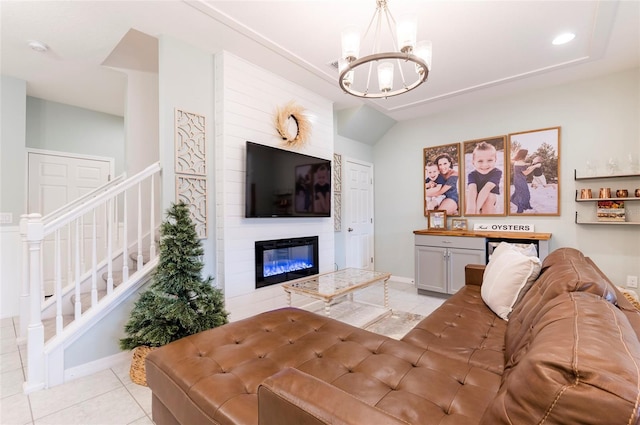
[0,282,443,425]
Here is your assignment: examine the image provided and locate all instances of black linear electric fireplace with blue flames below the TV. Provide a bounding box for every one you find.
[256,236,318,289]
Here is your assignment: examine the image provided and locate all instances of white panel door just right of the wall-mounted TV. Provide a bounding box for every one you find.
[343,160,374,270]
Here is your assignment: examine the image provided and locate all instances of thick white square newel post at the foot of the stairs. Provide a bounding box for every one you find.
[21,214,45,393]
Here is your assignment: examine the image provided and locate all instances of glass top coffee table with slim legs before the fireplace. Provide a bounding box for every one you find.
[282,268,391,316]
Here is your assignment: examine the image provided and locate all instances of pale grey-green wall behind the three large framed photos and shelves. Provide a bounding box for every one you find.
[374,69,640,284]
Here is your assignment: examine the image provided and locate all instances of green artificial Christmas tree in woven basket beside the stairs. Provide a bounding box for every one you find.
[120,202,228,385]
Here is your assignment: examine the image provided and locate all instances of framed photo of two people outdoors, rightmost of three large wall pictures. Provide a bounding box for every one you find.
[508,127,560,216]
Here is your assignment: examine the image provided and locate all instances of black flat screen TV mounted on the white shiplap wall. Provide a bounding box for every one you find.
[245,142,331,217]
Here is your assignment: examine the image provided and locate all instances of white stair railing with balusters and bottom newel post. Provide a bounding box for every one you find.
[19,163,161,393]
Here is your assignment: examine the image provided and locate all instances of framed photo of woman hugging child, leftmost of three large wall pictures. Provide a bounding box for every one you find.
[422,143,461,217]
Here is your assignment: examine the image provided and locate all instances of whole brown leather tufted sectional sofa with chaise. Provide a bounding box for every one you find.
[146,248,640,425]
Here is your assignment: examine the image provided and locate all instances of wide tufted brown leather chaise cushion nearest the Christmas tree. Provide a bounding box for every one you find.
[146,308,500,425]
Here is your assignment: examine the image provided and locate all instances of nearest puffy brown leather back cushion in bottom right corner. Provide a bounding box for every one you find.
[481,292,640,425]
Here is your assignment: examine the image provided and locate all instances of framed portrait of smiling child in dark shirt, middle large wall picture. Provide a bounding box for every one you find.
[462,135,509,217]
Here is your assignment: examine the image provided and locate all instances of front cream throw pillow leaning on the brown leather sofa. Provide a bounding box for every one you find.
[480,242,541,320]
